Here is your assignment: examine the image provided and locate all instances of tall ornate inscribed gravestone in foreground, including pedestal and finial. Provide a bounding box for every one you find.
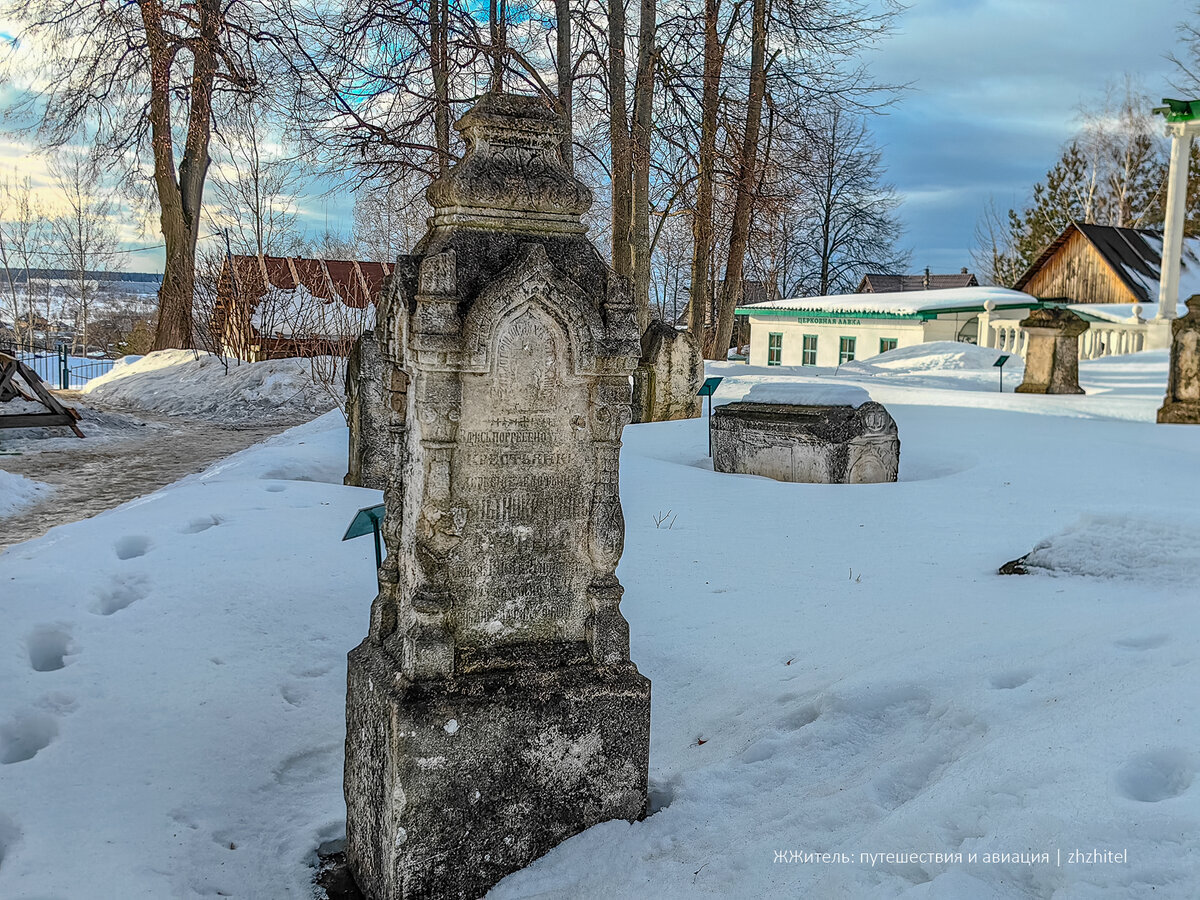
[346,95,650,900]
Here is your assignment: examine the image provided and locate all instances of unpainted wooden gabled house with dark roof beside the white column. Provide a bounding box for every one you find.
[1013,223,1200,305]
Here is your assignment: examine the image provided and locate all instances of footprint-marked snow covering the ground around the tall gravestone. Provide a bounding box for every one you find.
[0,346,1200,900]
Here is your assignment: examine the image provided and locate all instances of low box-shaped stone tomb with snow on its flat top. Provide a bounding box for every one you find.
[712,383,900,485]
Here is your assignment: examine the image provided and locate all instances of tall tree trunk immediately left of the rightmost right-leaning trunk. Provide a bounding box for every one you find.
[688,0,722,341]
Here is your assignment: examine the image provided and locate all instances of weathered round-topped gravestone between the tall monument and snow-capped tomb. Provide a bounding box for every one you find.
[634,322,704,422]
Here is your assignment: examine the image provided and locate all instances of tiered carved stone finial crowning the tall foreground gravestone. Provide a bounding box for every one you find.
[426,94,592,234]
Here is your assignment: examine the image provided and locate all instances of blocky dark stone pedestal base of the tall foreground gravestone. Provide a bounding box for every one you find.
[346,642,650,900]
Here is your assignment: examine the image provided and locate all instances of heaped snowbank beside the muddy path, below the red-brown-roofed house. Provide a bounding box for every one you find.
[83,350,343,422]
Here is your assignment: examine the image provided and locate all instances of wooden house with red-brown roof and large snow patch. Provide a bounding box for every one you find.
[211,256,394,360]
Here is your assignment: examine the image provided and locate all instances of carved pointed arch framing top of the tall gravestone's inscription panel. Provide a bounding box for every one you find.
[462,244,605,374]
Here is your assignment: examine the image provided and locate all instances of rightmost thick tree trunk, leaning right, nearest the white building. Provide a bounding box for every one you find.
[704,0,767,360]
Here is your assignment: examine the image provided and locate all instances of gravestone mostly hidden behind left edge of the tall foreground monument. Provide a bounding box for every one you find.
[344,331,394,491]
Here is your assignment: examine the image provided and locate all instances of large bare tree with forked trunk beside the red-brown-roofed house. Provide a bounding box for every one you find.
[2,0,270,349]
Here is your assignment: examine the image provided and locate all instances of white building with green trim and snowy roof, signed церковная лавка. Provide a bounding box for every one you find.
[737,287,1043,366]
